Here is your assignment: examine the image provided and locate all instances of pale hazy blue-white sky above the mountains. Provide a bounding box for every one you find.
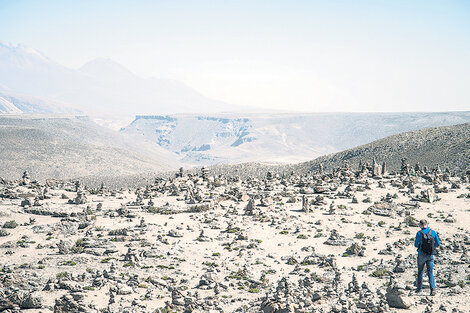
[0,0,470,111]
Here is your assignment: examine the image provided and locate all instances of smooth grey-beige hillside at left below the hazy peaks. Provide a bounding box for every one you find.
[0,116,178,179]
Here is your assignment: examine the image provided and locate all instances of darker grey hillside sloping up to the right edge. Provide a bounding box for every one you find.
[297,123,470,172]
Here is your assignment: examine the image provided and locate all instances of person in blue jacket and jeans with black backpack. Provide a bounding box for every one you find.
[415,219,441,296]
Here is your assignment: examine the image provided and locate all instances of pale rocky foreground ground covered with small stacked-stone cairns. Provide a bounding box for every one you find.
[0,159,470,313]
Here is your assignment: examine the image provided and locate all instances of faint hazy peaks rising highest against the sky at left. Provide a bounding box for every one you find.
[0,43,233,114]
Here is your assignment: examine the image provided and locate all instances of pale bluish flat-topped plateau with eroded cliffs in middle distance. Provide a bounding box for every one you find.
[122,112,470,165]
